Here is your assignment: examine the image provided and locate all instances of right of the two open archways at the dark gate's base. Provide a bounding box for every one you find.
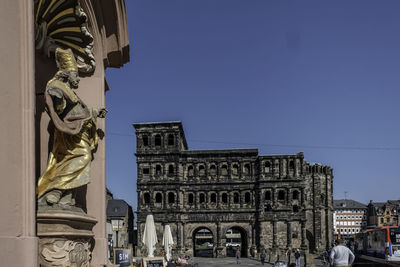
[225,227,247,258]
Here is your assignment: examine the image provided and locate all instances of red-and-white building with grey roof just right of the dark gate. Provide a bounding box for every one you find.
[333,199,367,238]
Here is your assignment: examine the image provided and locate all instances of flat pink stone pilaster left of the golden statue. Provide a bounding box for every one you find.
[0,0,38,267]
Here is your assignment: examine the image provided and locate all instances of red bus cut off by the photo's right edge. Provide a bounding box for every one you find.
[354,226,400,262]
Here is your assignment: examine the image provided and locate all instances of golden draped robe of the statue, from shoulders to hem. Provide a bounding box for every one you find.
[37,78,98,198]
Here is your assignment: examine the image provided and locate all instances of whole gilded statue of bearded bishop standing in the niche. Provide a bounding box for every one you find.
[36,48,107,209]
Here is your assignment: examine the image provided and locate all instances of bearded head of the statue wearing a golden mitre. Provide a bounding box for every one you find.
[56,47,79,88]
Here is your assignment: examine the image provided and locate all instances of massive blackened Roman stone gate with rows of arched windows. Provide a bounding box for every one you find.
[134,122,333,260]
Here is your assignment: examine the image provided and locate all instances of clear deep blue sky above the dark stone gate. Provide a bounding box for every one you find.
[106,0,400,211]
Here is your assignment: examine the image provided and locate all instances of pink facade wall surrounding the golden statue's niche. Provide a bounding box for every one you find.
[0,0,129,267]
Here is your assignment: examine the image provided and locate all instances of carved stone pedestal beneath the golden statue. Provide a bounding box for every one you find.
[37,210,97,267]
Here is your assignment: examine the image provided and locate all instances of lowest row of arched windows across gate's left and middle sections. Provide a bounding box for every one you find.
[142,191,253,208]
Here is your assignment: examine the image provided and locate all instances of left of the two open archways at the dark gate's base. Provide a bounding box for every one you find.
[193,227,214,258]
